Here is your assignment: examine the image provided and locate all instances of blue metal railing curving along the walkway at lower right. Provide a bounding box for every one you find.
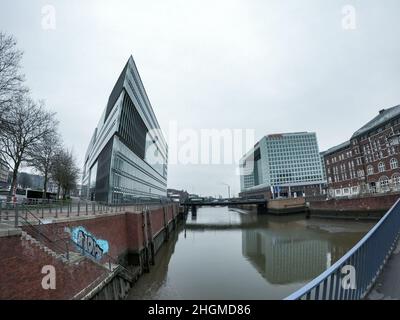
[285,199,400,300]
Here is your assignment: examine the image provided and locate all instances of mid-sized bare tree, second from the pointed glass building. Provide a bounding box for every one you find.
[28,128,61,199]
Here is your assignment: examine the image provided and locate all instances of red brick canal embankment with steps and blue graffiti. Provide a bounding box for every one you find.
[0,204,179,299]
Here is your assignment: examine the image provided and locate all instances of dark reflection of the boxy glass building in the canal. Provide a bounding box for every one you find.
[242,223,362,284]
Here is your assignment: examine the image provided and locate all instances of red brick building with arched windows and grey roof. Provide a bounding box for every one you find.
[322,105,400,197]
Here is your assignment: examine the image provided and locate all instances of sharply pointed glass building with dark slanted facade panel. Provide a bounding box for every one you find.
[82,56,168,203]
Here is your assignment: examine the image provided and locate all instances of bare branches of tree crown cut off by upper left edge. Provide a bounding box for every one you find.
[0,32,27,130]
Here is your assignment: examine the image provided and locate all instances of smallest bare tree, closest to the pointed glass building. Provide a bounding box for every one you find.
[52,149,80,199]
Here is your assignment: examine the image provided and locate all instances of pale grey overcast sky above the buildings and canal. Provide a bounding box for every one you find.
[0,0,400,195]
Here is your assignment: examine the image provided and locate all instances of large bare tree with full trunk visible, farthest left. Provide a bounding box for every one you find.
[0,95,56,196]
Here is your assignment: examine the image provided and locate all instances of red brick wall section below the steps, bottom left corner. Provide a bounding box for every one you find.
[0,236,107,299]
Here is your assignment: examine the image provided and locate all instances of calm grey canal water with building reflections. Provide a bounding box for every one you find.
[128,207,374,300]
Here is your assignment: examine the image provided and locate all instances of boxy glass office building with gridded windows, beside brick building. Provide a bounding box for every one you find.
[240,132,325,195]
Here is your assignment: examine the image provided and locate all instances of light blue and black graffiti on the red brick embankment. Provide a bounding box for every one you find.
[71,227,109,260]
